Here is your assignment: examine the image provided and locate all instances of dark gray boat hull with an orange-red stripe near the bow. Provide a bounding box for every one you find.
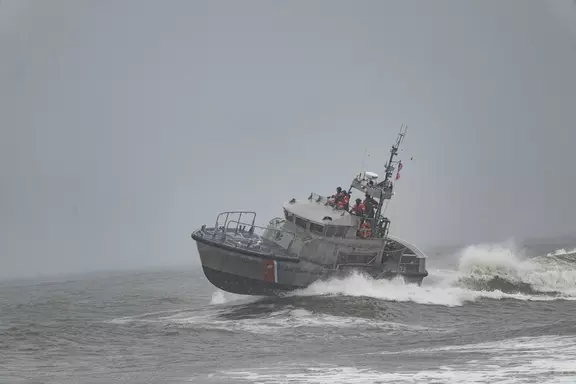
[192,231,428,296]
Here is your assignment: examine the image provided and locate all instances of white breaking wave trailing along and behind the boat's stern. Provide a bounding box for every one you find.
[293,244,576,306]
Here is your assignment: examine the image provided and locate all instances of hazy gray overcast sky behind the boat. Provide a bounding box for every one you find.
[0,0,576,276]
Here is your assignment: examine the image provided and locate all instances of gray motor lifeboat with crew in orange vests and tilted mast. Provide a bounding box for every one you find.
[191,126,428,296]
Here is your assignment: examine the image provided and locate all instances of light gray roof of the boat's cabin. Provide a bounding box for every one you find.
[283,200,357,227]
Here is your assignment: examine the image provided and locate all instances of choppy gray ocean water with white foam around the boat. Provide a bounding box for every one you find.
[0,245,576,384]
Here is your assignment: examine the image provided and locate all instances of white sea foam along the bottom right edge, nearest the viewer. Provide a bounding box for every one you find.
[222,336,576,384]
